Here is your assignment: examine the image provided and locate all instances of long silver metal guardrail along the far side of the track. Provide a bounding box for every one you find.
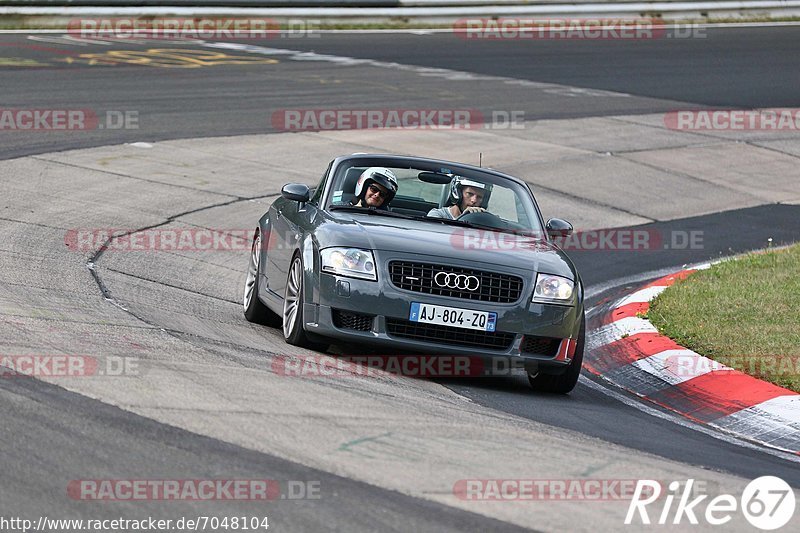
[0,0,800,23]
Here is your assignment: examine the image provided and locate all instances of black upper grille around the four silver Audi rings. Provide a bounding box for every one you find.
[389,261,523,303]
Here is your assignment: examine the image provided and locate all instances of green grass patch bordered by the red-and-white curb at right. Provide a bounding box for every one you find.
[647,245,800,392]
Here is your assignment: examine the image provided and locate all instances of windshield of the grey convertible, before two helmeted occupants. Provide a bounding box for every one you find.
[328,160,542,234]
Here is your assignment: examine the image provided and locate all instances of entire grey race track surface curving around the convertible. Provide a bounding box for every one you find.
[0,26,800,531]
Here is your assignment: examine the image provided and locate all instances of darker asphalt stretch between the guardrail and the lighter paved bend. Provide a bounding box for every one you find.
[0,27,800,158]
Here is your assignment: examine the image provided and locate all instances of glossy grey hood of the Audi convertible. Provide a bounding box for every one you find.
[316,213,576,279]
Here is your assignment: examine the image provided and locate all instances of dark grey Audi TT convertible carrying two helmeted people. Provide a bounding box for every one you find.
[244,154,585,393]
